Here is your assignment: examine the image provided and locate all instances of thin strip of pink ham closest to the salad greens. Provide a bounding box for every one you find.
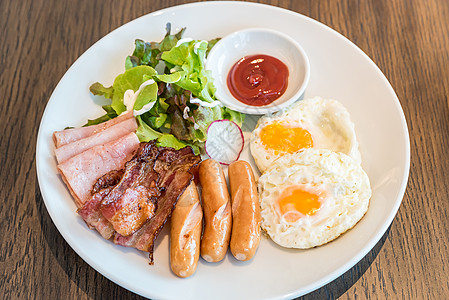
[53,111,133,148]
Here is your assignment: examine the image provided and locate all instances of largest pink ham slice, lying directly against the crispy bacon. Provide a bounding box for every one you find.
[58,132,139,207]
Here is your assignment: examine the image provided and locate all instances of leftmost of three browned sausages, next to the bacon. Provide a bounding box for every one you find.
[170,181,203,277]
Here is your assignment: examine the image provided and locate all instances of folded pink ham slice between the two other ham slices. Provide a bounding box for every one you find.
[55,118,137,164]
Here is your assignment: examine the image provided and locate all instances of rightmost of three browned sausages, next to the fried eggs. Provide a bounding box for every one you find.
[228,160,261,261]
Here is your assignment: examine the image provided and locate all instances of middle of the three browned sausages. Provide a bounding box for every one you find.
[198,159,232,262]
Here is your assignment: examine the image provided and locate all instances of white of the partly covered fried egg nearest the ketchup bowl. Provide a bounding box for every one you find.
[250,97,361,172]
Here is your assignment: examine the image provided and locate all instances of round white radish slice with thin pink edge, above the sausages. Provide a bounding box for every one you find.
[204,120,245,165]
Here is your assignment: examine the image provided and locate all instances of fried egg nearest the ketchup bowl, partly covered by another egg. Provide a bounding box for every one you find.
[250,97,361,172]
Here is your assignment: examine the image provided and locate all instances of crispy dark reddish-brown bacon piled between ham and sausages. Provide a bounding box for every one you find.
[78,142,201,264]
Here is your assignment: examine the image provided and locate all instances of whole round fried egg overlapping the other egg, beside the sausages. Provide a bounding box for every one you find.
[258,148,371,249]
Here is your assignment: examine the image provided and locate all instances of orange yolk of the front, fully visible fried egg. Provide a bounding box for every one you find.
[278,187,321,222]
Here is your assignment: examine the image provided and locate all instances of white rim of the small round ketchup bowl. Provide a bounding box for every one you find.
[205,27,311,115]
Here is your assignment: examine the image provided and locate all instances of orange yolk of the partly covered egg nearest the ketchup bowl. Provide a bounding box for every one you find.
[260,122,313,153]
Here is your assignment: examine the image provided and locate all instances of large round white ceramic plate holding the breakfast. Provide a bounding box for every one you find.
[36,2,410,299]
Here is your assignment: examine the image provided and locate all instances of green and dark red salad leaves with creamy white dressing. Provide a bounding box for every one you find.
[86,23,244,154]
